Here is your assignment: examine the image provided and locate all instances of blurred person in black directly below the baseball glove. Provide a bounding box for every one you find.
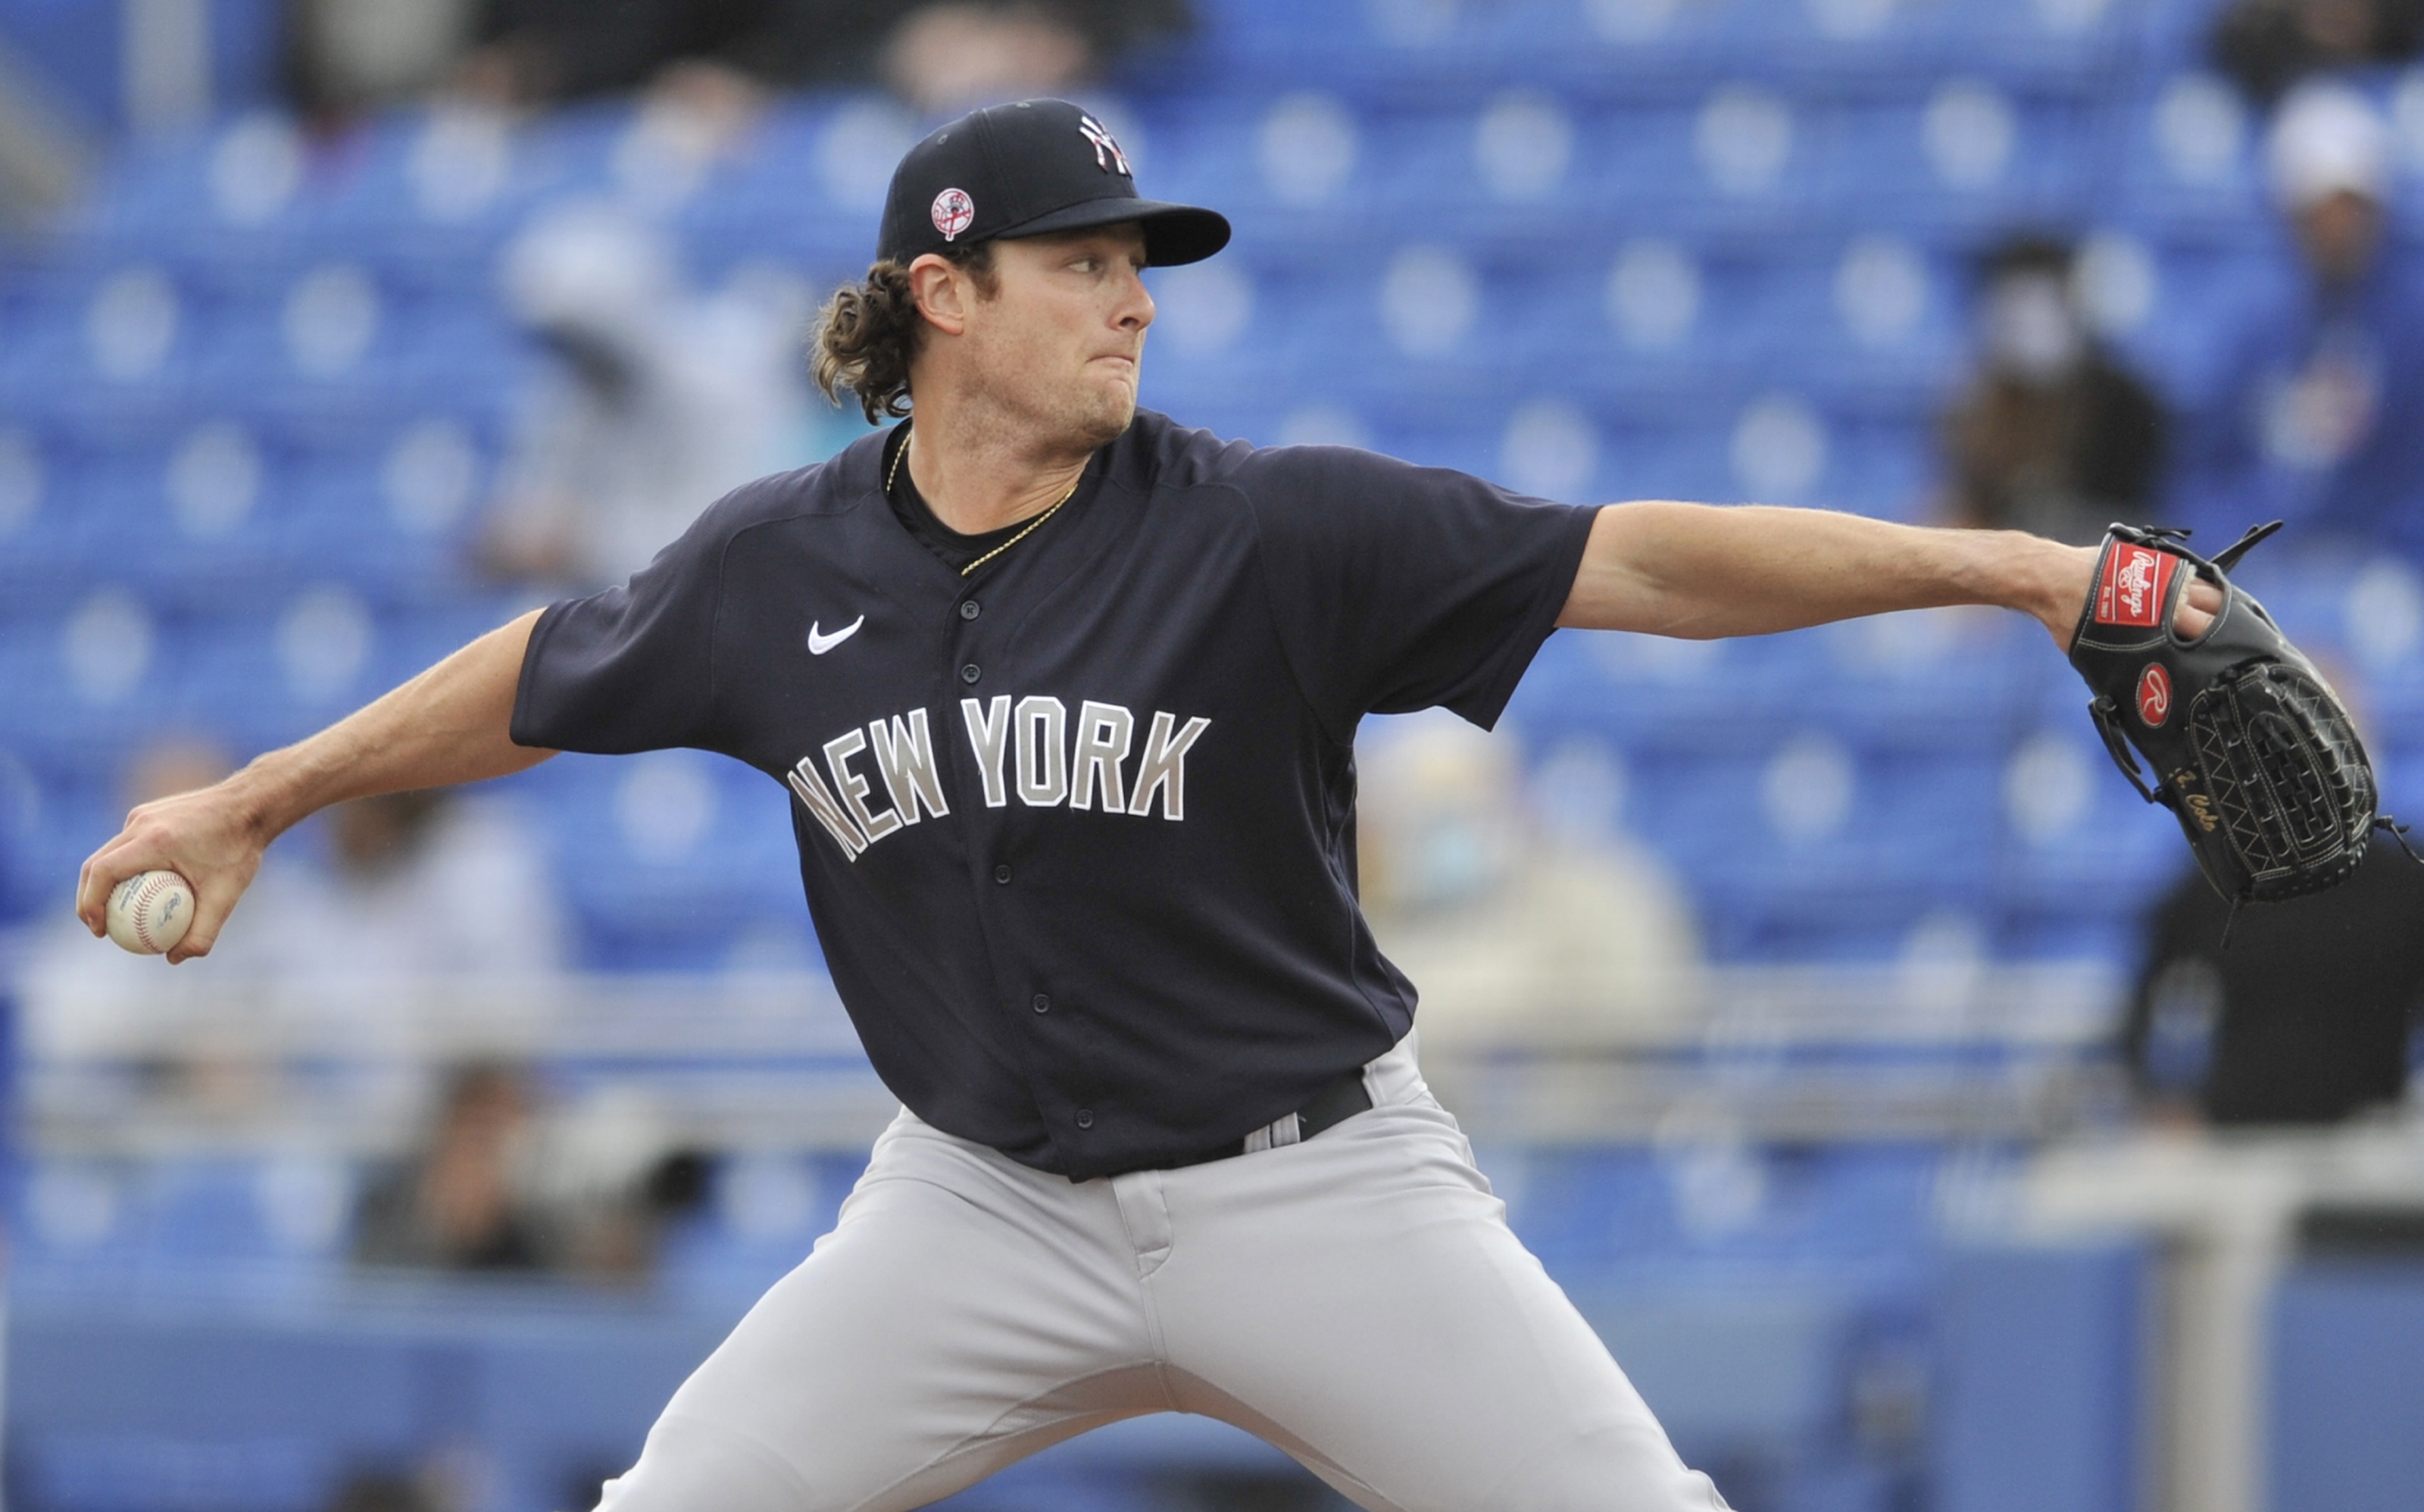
[2123,836,2424,1124]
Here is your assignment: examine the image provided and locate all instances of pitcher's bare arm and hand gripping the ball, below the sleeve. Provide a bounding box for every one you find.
[75,611,555,962]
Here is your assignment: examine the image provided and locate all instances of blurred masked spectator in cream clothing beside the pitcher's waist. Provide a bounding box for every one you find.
[1355,717,1699,1057]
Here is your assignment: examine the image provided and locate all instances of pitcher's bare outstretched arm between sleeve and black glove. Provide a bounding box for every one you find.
[1556,501,2220,651]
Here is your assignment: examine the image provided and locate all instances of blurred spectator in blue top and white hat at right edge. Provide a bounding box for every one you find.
[2189,85,2424,555]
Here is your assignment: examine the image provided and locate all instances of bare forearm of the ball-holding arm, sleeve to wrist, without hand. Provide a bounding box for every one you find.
[228,611,553,843]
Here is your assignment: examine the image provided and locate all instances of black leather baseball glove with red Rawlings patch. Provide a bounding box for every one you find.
[2070,521,2397,918]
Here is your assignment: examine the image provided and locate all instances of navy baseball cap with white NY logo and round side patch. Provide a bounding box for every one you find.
[875,99,1229,267]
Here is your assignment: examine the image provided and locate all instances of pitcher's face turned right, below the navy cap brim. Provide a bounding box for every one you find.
[965,223,1154,451]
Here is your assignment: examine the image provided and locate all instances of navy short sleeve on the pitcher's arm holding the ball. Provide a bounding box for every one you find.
[514,496,729,756]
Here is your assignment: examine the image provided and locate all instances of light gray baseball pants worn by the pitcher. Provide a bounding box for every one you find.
[601,1037,1726,1512]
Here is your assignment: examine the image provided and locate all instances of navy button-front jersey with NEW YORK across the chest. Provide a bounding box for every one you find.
[514,412,1592,1178]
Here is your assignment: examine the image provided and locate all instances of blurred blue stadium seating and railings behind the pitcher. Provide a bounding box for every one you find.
[0,0,2424,1512]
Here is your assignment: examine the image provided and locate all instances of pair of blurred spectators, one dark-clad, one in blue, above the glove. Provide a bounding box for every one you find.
[1941,80,2424,555]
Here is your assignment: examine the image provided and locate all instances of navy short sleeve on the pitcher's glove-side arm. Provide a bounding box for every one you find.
[1234,446,1598,739]
